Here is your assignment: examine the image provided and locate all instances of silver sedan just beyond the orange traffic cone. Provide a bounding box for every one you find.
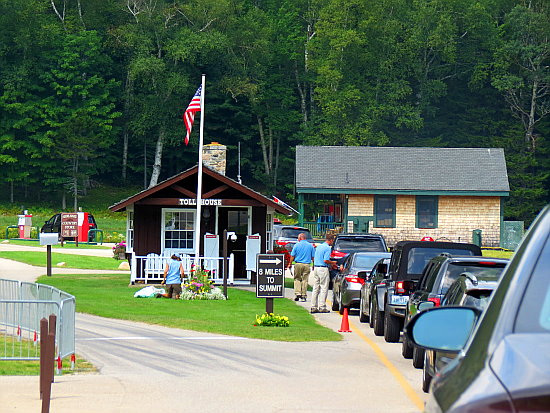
[332,252,391,314]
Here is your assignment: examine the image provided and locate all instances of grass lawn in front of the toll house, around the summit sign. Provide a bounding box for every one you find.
[38,274,342,341]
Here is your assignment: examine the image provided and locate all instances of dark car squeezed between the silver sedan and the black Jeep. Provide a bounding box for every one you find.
[359,258,390,336]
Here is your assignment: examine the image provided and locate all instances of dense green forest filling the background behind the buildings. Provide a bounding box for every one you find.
[0,0,550,221]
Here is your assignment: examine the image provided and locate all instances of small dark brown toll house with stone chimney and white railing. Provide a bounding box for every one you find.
[106,143,290,284]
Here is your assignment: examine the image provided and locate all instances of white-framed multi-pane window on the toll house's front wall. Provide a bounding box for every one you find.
[162,209,196,252]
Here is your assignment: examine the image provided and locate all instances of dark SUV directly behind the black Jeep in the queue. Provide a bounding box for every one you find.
[401,253,508,369]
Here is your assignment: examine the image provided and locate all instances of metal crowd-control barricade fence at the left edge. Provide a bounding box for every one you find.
[0,279,76,360]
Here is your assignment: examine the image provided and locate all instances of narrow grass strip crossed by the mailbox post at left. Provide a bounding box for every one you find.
[0,251,123,270]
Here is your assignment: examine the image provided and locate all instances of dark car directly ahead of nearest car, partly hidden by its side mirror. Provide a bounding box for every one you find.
[422,269,503,393]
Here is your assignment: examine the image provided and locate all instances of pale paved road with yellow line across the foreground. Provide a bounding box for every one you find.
[0,243,424,413]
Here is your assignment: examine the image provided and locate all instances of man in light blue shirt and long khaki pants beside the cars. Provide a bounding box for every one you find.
[311,234,336,313]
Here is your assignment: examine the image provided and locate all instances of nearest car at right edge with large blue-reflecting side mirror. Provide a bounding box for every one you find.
[405,205,550,413]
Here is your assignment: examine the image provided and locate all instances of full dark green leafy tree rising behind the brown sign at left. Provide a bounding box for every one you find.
[40,31,120,210]
